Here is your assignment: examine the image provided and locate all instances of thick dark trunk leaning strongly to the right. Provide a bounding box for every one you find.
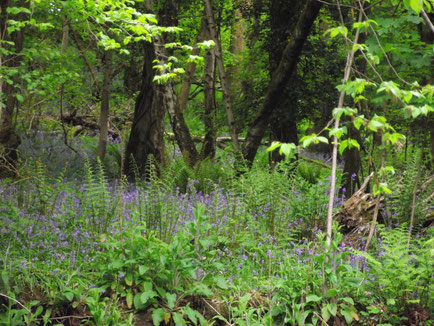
[243,0,322,163]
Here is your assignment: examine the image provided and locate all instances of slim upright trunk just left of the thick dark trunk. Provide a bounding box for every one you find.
[98,50,112,160]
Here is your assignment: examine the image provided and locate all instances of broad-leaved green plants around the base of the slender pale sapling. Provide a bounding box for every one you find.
[271,232,365,325]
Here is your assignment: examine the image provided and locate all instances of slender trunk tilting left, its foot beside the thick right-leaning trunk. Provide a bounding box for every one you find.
[203,0,240,152]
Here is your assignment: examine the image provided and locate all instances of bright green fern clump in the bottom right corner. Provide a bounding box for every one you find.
[357,224,434,323]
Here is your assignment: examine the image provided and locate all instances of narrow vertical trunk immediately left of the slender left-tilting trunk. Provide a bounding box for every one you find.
[201,19,216,158]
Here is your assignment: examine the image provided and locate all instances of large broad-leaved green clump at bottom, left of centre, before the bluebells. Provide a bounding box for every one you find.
[95,216,212,325]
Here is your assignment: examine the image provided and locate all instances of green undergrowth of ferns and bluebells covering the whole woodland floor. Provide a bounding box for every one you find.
[0,162,434,326]
